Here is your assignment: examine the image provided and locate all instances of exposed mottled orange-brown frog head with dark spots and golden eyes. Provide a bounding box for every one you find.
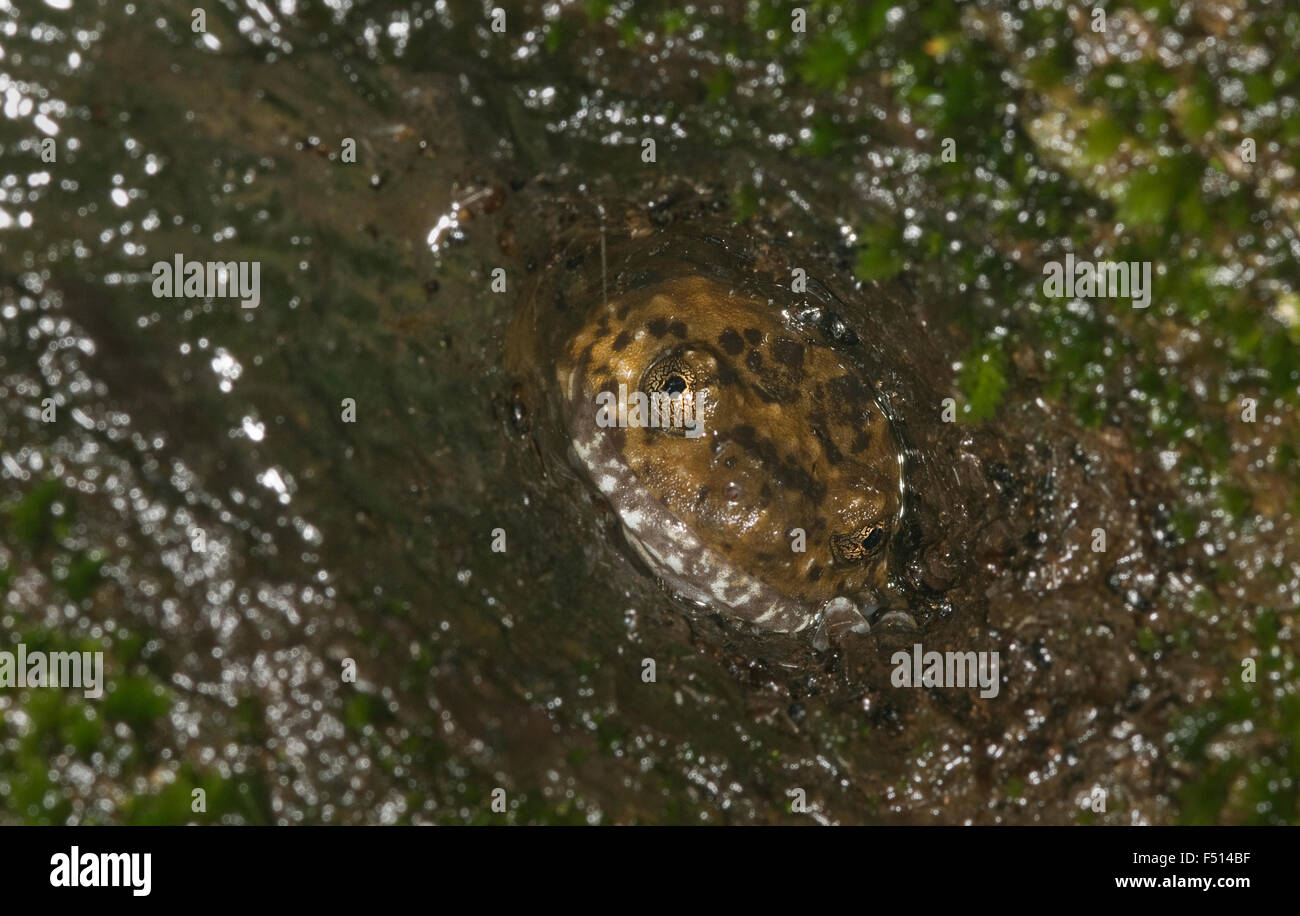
[555,275,901,630]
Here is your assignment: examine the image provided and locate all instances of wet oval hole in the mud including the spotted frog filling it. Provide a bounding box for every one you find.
[507,196,905,633]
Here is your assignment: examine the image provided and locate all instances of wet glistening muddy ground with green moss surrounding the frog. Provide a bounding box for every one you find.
[0,3,1300,824]
